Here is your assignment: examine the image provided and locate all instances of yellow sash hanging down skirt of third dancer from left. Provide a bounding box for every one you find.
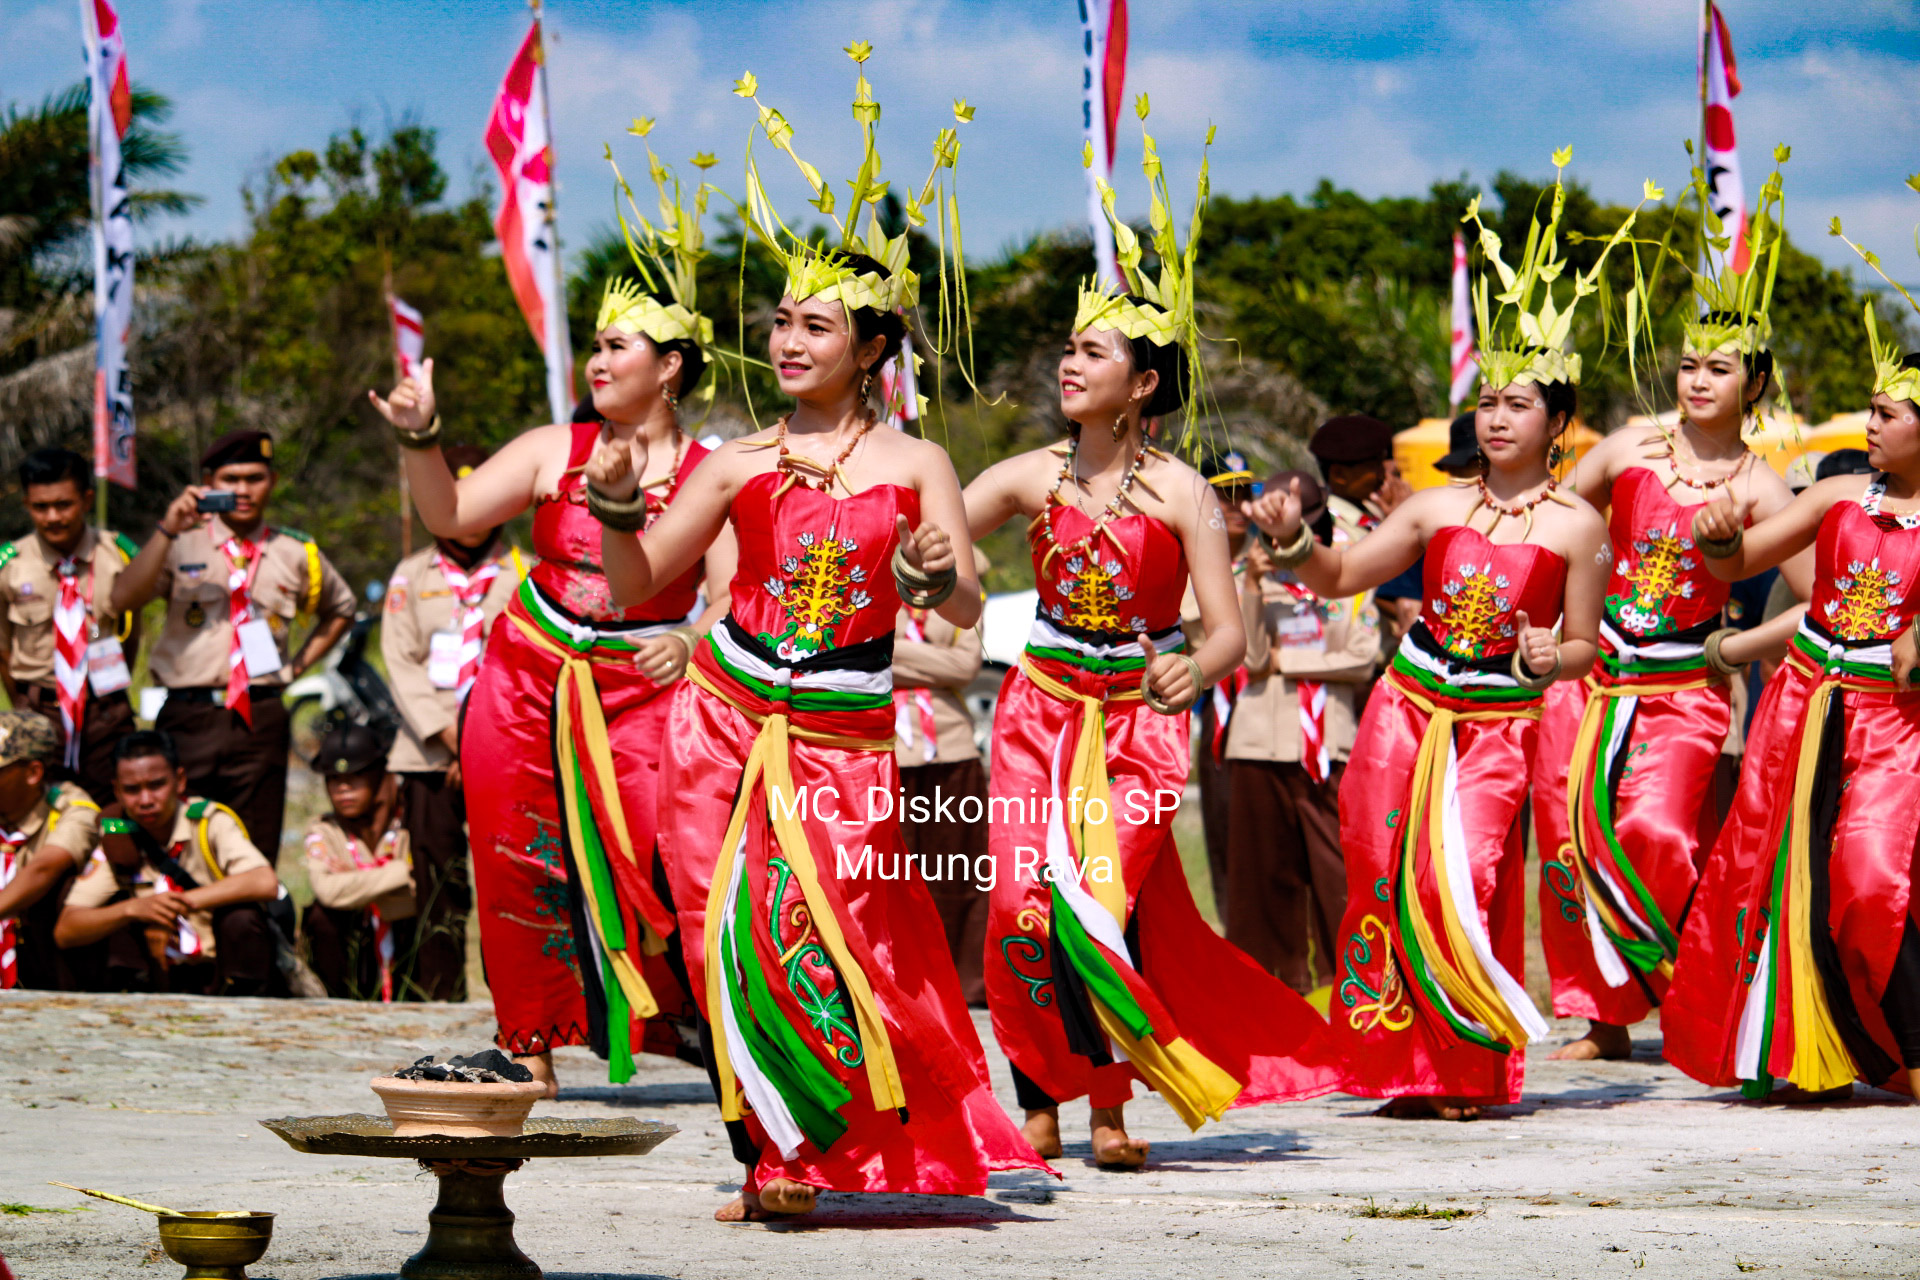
[1020,654,1246,1128]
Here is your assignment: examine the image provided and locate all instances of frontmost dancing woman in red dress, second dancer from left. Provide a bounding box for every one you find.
[588,55,1043,1221]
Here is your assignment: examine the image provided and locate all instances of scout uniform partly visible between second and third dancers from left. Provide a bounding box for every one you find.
[893,608,987,1004]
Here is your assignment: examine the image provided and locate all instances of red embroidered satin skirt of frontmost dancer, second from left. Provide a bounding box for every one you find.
[660,656,1046,1196]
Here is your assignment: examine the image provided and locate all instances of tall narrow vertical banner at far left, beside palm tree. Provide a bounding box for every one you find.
[81,0,134,489]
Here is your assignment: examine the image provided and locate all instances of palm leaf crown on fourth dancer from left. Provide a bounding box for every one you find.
[1461,146,1663,388]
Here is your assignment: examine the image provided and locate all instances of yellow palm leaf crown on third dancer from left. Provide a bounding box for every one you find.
[1073,94,1213,360]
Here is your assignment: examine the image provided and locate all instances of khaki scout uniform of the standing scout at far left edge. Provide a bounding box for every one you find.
[0,526,140,798]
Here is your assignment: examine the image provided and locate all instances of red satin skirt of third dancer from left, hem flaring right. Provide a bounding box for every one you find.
[987,662,1338,1125]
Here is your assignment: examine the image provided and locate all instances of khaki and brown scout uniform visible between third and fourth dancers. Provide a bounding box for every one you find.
[1221,503,1380,992]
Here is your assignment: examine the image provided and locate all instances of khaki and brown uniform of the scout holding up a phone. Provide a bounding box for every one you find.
[148,516,353,862]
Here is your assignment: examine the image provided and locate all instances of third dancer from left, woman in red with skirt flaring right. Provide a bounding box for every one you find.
[966,107,1336,1167]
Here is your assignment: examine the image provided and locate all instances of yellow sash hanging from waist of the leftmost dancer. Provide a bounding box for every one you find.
[507,612,666,1021]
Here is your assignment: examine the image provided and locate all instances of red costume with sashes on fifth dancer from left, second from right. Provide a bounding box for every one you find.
[1534,466,1732,1027]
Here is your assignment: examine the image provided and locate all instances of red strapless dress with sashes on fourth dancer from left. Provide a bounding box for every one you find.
[1332,526,1567,1103]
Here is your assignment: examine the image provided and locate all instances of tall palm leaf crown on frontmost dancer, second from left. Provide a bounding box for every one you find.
[733,40,973,311]
